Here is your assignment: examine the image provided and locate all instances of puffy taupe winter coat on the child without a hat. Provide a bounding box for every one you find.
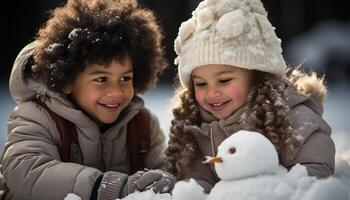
[1,41,166,200]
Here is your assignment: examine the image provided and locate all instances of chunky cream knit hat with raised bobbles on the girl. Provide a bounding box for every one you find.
[175,0,287,88]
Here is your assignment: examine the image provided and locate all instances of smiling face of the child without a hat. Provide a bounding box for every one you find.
[64,56,134,125]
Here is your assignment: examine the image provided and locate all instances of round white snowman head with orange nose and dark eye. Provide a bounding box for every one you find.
[207,131,279,181]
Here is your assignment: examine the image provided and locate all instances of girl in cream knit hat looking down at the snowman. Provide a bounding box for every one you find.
[166,0,335,193]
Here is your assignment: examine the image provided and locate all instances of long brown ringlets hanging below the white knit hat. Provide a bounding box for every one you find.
[165,70,300,180]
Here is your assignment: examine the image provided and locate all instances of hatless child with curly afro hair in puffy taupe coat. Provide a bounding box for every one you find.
[1,0,175,200]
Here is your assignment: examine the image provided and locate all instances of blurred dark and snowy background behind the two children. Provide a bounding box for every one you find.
[0,0,350,152]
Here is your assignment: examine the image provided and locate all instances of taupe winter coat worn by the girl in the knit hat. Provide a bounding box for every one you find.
[185,76,335,193]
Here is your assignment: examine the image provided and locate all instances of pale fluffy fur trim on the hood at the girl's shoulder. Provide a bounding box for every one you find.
[289,69,327,103]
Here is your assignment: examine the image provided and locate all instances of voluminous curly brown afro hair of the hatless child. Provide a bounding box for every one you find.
[32,0,167,93]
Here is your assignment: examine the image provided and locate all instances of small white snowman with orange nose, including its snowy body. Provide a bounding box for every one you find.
[205,131,316,200]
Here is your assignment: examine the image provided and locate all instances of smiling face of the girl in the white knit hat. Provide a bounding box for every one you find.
[192,65,251,119]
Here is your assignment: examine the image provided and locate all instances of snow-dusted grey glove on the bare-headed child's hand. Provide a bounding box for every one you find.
[123,169,176,196]
